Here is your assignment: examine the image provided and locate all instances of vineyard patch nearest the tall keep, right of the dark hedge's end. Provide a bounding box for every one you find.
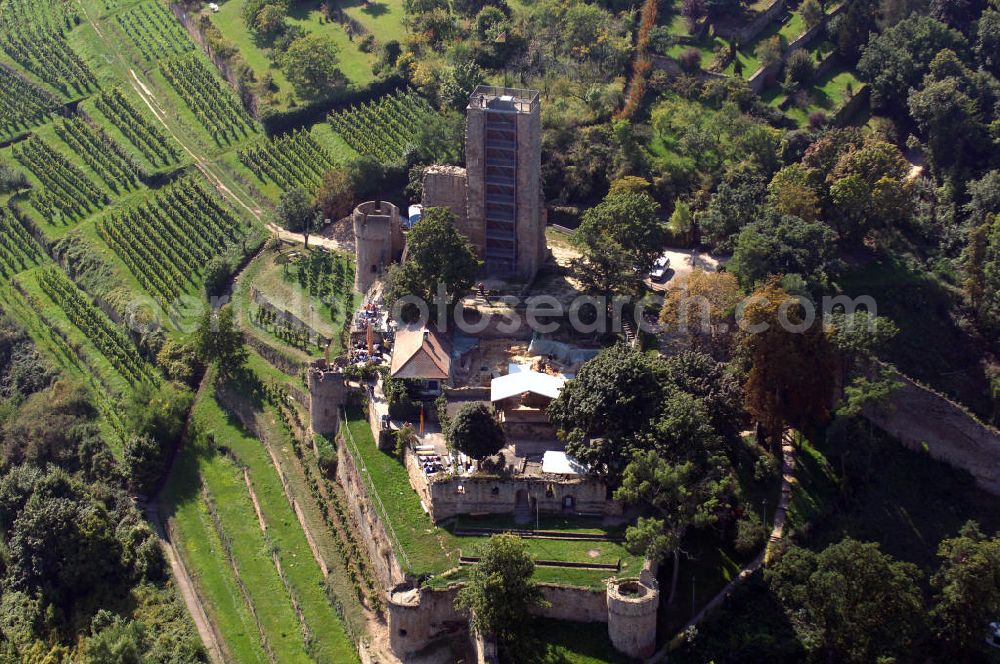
[328,90,435,164]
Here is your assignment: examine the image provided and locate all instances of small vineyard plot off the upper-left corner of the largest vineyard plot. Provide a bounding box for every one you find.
[12,135,108,225]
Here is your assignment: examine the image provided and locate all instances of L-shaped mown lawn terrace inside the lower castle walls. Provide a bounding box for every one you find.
[347,410,642,588]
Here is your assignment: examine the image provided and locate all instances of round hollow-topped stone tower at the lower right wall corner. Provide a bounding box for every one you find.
[608,575,660,659]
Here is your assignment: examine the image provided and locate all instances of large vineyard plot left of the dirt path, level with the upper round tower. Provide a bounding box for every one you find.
[97,178,248,305]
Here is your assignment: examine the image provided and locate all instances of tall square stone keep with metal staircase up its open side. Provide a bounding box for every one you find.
[464,85,546,281]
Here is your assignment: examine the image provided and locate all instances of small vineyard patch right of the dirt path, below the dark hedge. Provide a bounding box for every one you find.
[239,131,335,189]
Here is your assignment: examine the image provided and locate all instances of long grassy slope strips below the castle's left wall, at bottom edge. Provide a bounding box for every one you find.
[163,391,357,664]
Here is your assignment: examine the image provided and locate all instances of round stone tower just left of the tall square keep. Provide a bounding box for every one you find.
[352,201,403,293]
